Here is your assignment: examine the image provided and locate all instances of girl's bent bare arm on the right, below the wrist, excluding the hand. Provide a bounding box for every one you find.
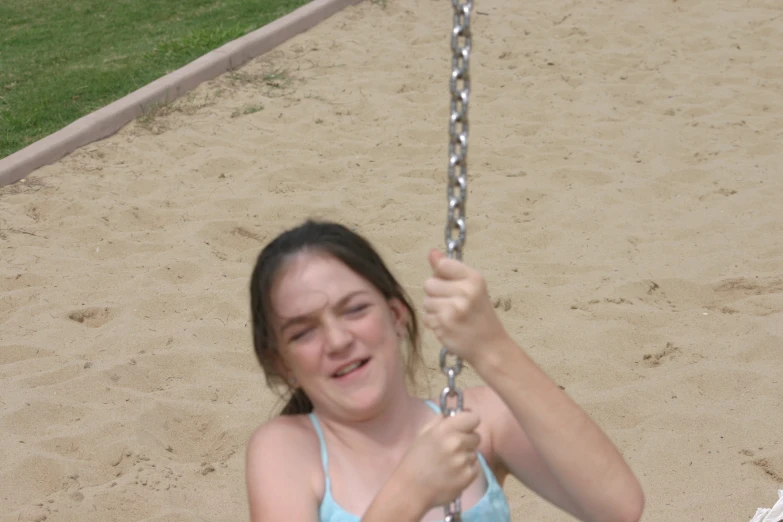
[475,337,644,522]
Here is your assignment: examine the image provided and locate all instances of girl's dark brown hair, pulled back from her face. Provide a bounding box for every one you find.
[250,220,421,415]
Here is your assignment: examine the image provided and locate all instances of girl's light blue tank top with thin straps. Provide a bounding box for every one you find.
[308,401,511,522]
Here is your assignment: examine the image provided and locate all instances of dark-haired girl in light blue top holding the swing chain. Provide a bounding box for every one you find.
[246,221,644,522]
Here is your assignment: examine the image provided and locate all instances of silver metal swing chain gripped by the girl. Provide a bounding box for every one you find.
[440,0,473,522]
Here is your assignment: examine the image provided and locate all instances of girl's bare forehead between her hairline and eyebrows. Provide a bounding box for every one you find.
[271,252,377,317]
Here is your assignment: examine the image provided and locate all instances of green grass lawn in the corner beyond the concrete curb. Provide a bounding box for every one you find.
[0,0,307,158]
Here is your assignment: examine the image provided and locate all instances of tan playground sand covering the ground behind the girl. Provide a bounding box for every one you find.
[0,0,783,522]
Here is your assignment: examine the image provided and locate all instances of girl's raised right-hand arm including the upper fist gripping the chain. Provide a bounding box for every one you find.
[424,251,644,522]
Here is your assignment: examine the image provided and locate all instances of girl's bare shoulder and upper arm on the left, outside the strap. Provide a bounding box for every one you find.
[245,415,324,522]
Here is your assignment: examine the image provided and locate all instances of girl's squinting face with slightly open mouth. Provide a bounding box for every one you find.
[271,252,407,420]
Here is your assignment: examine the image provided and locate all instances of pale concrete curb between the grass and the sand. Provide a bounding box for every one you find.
[0,0,362,187]
